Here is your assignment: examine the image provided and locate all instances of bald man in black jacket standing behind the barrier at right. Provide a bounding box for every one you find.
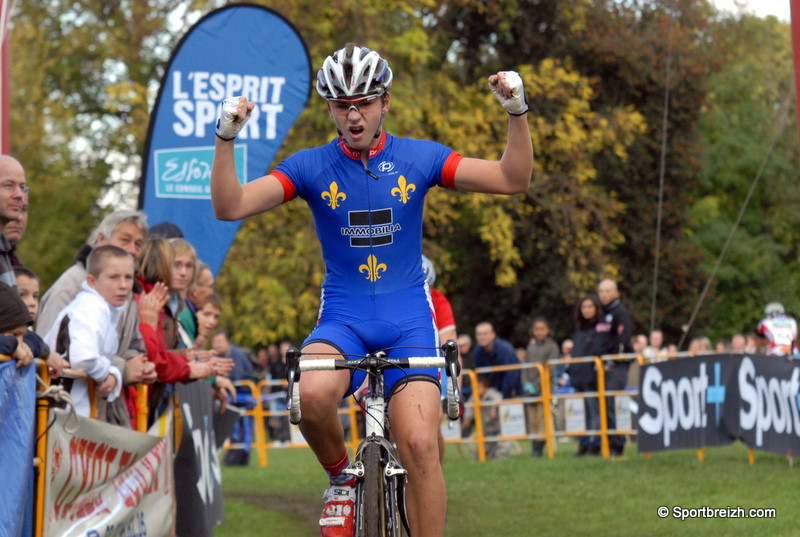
[597,279,636,456]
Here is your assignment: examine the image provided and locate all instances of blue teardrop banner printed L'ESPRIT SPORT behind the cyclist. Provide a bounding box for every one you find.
[139,4,311,274]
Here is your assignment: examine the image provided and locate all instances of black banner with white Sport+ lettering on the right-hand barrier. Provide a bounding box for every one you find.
[637,354,800,454]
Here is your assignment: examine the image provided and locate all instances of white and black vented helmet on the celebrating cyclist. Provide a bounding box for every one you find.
[317,43,392,99]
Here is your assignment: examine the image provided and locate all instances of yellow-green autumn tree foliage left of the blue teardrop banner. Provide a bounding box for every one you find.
[9,0,217,288]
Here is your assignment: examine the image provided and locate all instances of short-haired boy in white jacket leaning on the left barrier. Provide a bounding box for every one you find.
[45,245,133,416]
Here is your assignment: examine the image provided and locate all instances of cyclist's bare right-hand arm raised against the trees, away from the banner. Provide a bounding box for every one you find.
[455,73,533,194]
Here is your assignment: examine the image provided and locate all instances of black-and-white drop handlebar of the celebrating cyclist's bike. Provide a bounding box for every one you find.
[286,339,461,425]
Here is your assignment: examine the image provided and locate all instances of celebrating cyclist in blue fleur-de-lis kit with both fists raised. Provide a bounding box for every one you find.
[211,43,533,537]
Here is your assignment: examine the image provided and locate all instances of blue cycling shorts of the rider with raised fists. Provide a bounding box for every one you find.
[303,287,441,397]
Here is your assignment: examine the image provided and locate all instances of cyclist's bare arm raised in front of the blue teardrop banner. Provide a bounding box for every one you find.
[211,97,283,220]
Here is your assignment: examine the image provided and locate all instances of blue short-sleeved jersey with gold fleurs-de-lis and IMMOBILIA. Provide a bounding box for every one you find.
[272,132,461,298]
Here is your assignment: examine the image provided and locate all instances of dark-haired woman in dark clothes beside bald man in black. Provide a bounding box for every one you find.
[568,294,614,456]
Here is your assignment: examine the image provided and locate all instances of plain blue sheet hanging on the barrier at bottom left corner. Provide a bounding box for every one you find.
[0,360,36,537]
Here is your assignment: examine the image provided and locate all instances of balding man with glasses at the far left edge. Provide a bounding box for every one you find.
[0,155,30,287]
